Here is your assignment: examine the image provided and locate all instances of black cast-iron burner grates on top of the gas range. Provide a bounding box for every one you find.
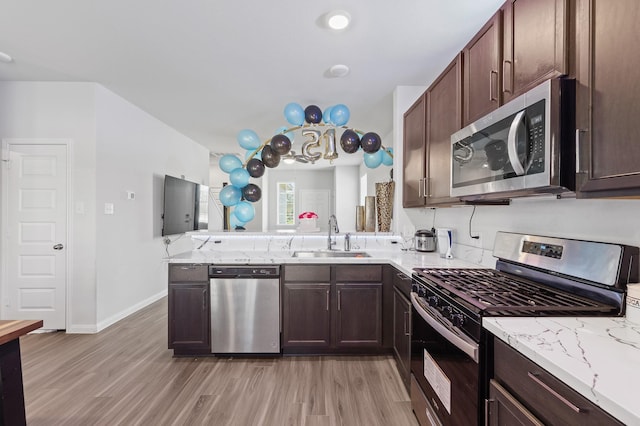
[416,268,616,315]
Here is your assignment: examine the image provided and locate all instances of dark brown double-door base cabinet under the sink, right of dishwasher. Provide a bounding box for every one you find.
[282,265,384,354]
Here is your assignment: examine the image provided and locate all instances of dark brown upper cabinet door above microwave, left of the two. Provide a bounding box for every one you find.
[462,11,502,126]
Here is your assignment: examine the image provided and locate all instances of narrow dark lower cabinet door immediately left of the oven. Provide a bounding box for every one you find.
[393,287,411,389]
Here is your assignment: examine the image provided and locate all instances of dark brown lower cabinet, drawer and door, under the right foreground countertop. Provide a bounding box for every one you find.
[487,338,623,426]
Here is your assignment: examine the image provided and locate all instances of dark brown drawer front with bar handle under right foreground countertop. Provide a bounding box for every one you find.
[494,338,622,426]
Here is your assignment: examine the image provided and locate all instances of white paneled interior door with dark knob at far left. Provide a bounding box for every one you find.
[2,142,68,329]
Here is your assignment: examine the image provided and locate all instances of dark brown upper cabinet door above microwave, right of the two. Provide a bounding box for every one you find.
[502,0,569,103]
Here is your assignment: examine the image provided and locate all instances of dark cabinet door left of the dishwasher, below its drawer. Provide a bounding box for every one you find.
[168,282,211,353]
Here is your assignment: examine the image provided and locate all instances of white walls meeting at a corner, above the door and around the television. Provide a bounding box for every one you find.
[0,82,209,332]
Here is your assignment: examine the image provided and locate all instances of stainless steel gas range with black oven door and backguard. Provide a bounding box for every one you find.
[411,232,638,425]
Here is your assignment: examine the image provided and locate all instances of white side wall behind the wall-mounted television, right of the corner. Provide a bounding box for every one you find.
[95,86,209,329]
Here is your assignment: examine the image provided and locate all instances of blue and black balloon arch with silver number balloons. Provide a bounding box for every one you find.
[218,102,393,229]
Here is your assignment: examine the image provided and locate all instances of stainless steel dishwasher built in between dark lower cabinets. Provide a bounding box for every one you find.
[209,265,280,354]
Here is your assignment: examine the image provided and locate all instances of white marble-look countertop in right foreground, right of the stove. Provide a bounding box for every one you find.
[482,317,640,425]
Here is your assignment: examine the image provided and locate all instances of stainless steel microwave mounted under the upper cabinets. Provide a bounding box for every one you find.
[451,78,576,200]
